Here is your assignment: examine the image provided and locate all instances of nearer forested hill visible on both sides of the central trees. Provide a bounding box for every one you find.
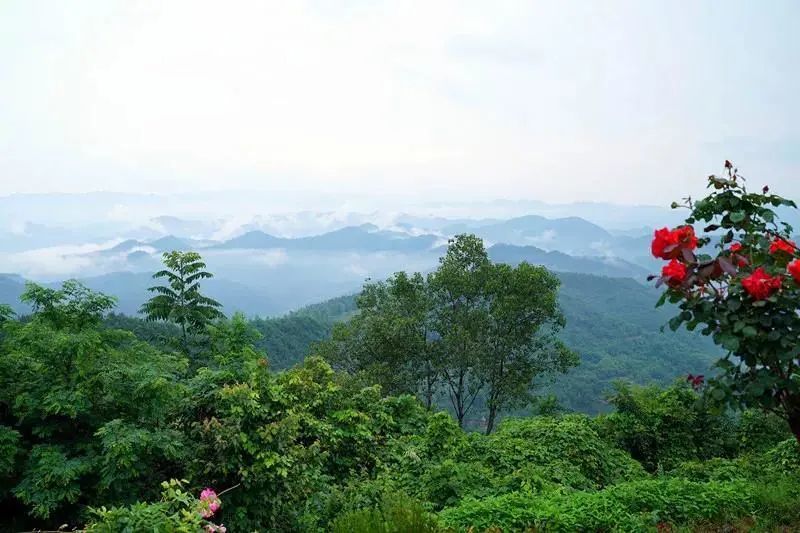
[247,273,717,413]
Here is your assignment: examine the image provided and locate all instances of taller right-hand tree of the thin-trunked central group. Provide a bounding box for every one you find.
[430,235,578,434]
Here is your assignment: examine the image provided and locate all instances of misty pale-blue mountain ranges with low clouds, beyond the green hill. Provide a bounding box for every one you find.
[0,193,676,315]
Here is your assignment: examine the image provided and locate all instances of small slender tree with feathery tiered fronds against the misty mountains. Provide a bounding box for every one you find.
[139,251,225,351]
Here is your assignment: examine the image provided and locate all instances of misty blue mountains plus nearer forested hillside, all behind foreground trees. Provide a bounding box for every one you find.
[0,194,736,412]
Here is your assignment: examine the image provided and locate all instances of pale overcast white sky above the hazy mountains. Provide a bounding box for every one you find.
[0,0,800,205]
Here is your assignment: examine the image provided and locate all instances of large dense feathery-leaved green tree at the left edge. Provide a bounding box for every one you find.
[0,281,187,530]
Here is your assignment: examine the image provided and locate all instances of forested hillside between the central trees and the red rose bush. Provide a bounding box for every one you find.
[549,273,719,413]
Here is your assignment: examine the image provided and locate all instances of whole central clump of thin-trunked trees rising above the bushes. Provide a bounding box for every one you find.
[324,235,577,433]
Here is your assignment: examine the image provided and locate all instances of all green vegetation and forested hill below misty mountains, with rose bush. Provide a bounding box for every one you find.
[0,177,800,532]
